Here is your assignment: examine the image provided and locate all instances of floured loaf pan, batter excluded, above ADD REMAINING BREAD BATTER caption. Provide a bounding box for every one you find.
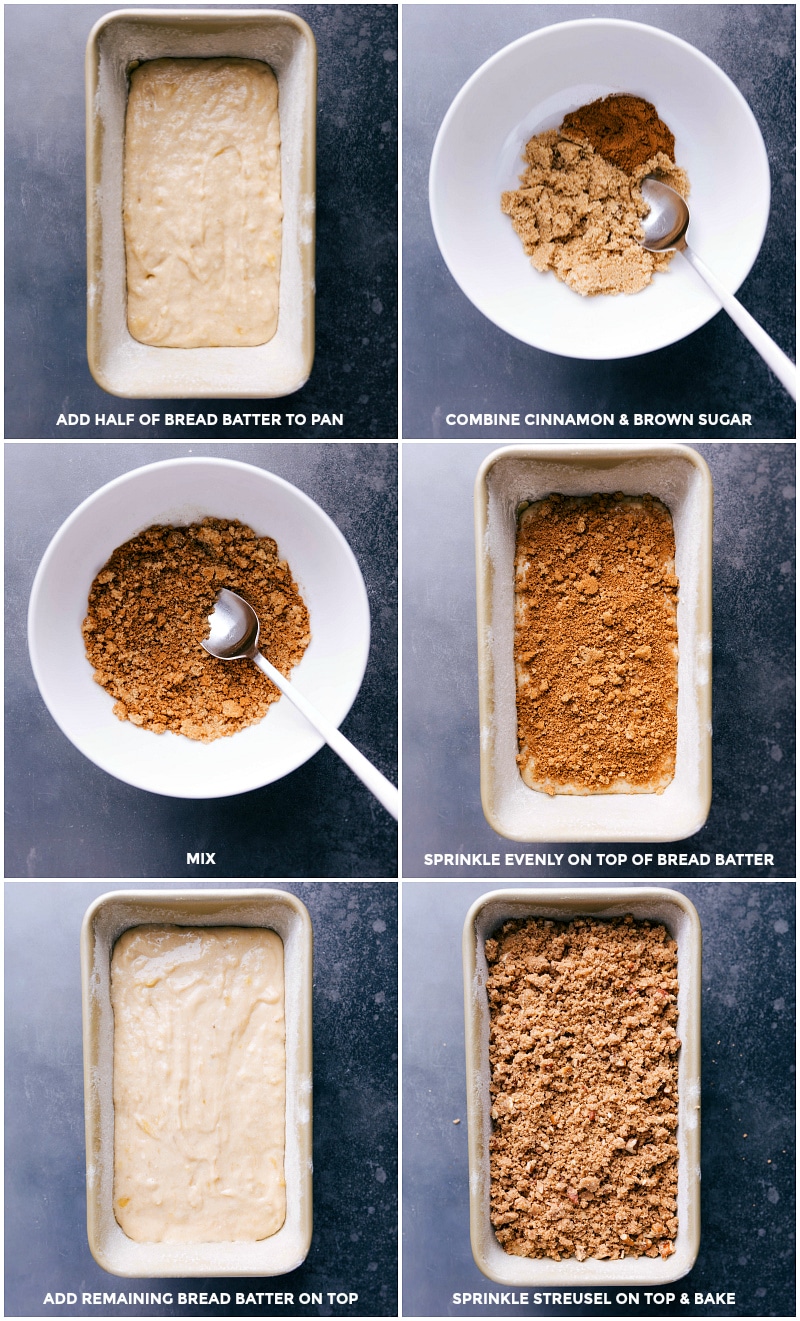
[81,890,313,1277]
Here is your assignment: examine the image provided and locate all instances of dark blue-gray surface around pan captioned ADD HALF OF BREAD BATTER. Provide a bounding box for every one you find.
[5,4,397,440]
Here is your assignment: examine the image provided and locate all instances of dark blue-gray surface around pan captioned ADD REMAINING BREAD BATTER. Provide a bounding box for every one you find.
[4,881,397,1317]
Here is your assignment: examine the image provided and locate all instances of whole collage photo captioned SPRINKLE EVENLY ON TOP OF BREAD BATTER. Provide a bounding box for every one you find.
[403,443,795,878]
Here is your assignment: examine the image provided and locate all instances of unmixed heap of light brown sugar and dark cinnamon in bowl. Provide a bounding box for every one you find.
[500,95,689,297]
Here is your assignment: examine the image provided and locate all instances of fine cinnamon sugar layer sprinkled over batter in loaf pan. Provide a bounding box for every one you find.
[514,493,679,795]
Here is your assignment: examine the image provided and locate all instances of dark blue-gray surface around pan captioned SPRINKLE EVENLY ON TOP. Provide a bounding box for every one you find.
[403,441,796,877]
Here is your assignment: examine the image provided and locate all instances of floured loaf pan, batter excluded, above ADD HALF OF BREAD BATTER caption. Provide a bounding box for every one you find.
[86,9,317,399]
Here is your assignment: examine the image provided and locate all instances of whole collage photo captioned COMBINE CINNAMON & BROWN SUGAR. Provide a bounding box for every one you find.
[401,4,796,440]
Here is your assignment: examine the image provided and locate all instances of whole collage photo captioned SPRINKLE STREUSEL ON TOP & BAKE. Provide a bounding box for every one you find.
[403,881,795,1317]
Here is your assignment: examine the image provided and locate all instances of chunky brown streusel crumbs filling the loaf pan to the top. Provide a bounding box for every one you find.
[486,915,680,1262]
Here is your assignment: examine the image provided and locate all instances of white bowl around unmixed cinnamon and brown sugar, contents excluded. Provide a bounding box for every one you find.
[430,18,770,359]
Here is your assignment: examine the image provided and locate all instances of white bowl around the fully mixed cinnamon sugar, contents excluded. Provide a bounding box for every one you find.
[28,458,370,798]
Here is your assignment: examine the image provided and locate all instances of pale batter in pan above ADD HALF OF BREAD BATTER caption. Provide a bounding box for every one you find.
[123,58,283,349]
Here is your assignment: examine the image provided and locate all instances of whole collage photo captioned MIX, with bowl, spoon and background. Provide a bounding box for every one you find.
[5,444,397,880]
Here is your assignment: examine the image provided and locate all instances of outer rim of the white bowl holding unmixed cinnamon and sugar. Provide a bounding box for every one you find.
[428,17,772,362]
